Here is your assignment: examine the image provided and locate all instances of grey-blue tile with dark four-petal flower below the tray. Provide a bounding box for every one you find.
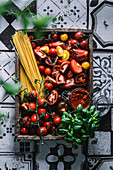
[36,140,85,170]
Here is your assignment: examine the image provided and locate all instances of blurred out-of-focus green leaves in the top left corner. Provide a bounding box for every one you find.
[0,0,51,38]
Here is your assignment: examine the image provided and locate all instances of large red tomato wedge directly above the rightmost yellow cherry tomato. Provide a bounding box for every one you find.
[72,49,88,61]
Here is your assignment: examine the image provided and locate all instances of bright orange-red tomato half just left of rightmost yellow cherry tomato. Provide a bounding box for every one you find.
[70,59,82,74]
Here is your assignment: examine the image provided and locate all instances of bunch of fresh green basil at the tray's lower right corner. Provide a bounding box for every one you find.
[59,104,100,148]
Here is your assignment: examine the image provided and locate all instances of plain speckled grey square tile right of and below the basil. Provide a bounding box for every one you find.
[88,131,111,155]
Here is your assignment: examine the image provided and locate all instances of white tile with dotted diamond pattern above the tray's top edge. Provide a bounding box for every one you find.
[37,0,87,28]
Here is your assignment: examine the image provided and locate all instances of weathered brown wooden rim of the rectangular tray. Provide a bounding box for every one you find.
[15,29,93,140]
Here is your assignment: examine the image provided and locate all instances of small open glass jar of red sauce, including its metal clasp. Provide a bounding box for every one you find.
[63,88,91,109]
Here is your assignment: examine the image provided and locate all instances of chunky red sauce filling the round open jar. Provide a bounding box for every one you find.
[70,89,90,109]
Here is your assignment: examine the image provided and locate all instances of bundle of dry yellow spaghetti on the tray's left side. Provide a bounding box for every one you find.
[13,31,43,95]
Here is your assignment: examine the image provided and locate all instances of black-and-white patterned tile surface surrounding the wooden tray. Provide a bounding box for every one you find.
[0,0,113,170]
